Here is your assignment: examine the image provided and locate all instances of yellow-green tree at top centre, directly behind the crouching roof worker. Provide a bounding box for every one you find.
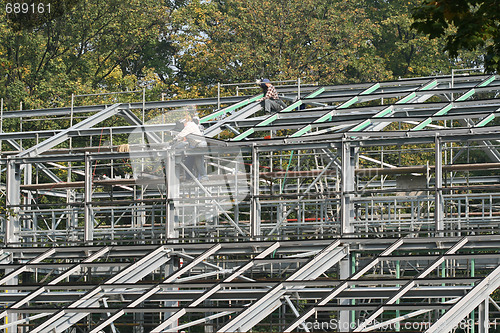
[176,0,390,84]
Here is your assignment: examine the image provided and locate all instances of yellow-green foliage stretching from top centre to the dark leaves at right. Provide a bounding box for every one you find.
[174,0,482,90]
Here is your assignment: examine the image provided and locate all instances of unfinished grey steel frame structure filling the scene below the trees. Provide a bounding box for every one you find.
[0,75,500,333]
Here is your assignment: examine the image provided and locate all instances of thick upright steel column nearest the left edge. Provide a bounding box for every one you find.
[5,159,21,245]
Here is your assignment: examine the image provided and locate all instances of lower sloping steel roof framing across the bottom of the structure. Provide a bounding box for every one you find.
[0,235,500,332]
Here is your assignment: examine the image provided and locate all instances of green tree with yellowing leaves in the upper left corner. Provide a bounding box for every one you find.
[0,0,184,108]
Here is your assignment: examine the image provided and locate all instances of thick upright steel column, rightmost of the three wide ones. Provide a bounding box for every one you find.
[340,139,356,235]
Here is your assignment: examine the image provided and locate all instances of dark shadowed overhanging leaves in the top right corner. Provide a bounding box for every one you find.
[412,0,500,72]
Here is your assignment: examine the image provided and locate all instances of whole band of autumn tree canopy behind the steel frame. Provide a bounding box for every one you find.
[0,0,492,109]
